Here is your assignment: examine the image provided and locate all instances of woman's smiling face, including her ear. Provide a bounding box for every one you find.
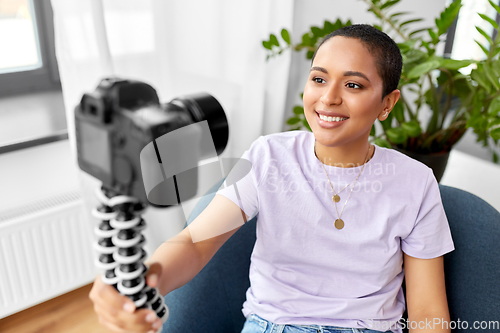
[303,36,399,149]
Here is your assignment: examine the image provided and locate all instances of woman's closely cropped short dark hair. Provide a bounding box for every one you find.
[311,24,403,99]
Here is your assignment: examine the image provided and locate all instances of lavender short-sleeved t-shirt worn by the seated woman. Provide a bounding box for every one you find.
[218,131,454,332]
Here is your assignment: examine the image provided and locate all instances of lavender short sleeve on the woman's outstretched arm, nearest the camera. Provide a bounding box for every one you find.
[216,136,266,219]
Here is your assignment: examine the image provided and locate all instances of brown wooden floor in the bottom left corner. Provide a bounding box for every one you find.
[0,284,110,333]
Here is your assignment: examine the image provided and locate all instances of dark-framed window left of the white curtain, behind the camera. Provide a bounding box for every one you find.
[0,0,67,153]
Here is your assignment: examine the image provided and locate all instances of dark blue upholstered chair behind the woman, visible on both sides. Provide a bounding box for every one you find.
[163,183,500,333]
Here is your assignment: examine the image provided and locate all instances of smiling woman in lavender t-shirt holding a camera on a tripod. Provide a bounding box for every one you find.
[90,25,454,333]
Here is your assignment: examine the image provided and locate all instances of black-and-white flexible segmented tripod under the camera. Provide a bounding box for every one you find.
[92,187,169,332]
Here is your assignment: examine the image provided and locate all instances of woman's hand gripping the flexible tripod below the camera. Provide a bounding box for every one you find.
[89,263,162,333]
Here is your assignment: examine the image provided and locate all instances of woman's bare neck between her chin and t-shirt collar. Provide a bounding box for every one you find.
[314,141,375,168]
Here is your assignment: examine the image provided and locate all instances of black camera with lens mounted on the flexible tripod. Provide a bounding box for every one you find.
[75,78,229,207]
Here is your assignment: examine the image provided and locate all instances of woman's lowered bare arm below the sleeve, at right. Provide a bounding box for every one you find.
[403,253,451,333]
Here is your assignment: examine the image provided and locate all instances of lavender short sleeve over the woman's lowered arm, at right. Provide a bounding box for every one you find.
[401,169,455,259]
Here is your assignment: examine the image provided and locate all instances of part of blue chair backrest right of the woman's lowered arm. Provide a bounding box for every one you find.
[440,185,500,332]
